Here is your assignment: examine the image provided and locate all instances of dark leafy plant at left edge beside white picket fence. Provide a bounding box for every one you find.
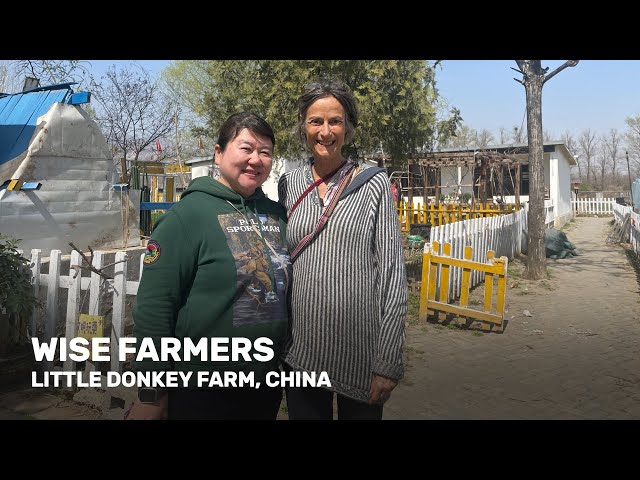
[0,234,41,385]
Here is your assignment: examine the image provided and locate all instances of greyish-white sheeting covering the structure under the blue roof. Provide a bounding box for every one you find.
[0,103,140,256]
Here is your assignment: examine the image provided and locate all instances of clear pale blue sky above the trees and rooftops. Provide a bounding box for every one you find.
[85,60,640,141]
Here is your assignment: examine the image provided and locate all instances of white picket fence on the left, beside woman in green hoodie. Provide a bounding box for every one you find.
[24,249,144,372]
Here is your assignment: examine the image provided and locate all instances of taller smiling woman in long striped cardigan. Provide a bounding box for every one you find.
[278,80,407,420]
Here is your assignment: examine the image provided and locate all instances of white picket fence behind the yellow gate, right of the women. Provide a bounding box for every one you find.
[425,208,528,298]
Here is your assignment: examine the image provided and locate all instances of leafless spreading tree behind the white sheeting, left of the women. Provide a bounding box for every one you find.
[93,66,177,169]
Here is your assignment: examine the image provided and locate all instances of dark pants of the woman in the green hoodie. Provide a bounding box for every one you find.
[169,384,282,420]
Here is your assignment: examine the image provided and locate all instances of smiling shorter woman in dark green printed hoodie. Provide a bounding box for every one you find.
[127,112,291,419]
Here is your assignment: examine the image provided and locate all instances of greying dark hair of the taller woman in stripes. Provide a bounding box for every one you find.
[297,79,358,145]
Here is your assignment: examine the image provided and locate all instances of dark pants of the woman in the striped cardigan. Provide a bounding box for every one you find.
[285,387,382,420]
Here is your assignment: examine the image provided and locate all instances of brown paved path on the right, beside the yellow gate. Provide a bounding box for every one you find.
[384,217,640,419]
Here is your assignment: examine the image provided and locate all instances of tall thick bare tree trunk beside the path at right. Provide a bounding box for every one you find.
[513,60,578,280]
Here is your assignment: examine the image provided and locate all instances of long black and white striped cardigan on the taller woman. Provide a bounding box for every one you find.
[278,163,407,402]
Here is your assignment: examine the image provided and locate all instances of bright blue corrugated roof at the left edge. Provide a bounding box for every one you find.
[0,83,73,165]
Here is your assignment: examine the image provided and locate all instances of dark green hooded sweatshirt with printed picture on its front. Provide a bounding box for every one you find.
[133,177,291,386]
